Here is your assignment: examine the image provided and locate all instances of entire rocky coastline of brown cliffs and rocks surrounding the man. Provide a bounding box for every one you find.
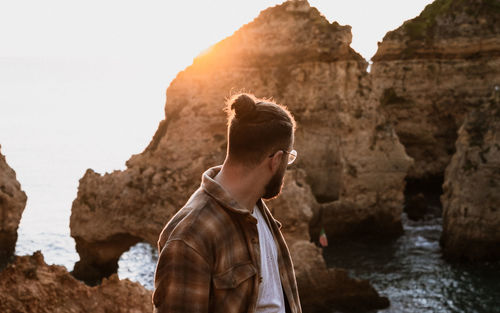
[0,0,500,312]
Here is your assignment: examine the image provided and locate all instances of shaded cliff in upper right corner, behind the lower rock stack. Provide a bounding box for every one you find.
[371,0,500,179]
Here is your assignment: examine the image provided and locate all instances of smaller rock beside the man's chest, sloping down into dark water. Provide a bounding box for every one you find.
[268,170,389,312]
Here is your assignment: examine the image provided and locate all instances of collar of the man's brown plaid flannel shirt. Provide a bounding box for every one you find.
[201,165,265,215]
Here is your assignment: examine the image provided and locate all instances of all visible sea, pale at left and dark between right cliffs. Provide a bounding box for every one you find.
[0,58,500,313]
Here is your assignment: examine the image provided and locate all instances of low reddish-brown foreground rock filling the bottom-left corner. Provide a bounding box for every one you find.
[0,252,153,313]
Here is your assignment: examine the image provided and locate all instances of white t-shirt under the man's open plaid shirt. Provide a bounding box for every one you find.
[252,206,285,313]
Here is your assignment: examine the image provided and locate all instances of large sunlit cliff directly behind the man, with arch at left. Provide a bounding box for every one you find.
[70,1,411,280]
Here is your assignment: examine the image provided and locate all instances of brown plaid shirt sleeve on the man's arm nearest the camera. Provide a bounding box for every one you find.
[153,240,211,313]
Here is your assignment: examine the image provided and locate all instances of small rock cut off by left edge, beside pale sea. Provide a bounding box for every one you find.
[0,146,27,268]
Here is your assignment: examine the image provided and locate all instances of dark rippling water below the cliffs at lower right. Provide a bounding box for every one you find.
[324,214,500,313]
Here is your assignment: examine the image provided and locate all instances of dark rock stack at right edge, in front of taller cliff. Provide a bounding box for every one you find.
[441,87,500,260]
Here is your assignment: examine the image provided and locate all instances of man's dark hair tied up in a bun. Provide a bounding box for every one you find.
[225,93,295,164]
